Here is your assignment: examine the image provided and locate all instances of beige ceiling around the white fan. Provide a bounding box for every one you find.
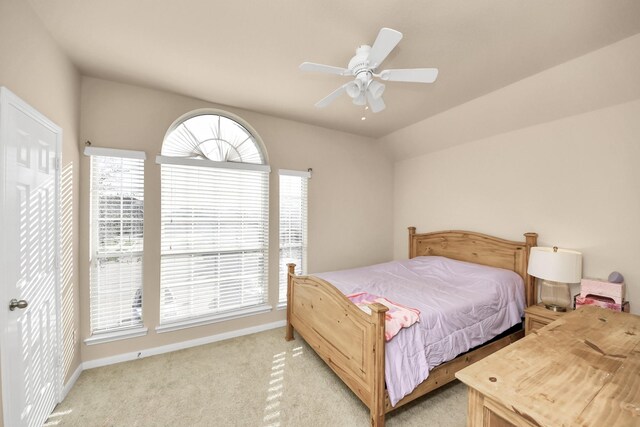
[28,0,640,137]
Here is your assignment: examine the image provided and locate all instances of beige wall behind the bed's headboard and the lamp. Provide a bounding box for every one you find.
[381,35,640,313]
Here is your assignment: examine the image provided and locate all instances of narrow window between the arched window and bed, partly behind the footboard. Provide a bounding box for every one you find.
[278,170,310,305]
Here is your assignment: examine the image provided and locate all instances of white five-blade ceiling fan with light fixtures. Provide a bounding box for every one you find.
[300,28,438,113]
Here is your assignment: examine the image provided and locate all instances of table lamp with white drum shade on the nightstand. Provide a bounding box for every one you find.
[527,246,582,311]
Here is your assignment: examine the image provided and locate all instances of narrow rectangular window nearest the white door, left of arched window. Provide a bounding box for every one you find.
[85,147,146,343]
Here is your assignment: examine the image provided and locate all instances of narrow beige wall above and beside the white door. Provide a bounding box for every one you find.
[0,0,80,424]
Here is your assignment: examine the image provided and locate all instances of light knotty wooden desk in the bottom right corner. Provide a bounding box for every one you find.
[456,307,640,427]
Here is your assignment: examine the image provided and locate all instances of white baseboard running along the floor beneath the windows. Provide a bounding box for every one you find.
[82,320,287,372]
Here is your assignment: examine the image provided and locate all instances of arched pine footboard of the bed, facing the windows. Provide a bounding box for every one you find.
[286,264,388,427]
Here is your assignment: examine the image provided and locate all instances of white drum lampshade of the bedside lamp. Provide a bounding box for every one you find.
[527,247,582,283]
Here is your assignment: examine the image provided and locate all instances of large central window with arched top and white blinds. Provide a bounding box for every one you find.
[156,110,270,330]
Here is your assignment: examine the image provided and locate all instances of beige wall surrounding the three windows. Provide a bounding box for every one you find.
[79,78,393,361]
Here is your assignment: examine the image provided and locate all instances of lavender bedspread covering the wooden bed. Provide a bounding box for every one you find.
[314,256,525,406]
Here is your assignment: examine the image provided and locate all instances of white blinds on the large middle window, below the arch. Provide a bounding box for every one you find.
[160,163,269,324]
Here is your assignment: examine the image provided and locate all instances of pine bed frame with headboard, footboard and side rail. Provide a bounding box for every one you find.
[285,227,538,427]
